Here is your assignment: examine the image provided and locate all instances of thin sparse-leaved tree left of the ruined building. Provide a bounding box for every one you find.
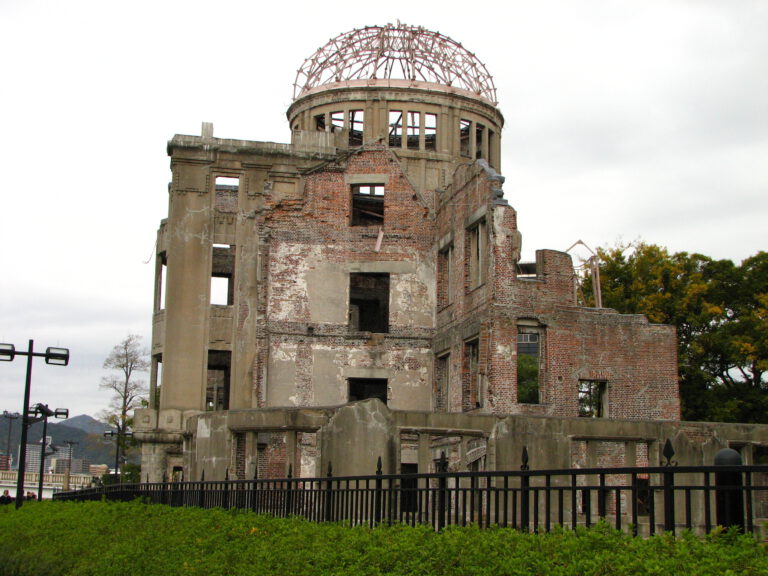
[99,334,149,472]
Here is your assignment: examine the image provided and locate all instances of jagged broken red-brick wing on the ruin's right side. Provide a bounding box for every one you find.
[437,160,680,420]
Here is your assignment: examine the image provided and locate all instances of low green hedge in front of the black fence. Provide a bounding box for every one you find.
[0,502,768,576]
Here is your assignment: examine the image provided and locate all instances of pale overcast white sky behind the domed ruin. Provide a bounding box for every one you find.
[0,0,768,414]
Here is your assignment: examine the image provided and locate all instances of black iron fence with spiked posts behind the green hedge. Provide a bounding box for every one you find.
[54,452,768,536]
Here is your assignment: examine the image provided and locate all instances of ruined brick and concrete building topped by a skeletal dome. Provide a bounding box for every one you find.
[135,24,768,480]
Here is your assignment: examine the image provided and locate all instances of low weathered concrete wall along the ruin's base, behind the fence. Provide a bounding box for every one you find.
[178,400,768,479]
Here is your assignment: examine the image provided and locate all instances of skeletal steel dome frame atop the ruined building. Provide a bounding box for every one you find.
[293,22,497,106]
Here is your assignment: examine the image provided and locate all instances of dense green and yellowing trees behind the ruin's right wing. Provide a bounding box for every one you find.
[585,242,768,422]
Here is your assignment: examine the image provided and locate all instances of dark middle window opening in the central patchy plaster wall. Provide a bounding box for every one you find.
[349,273,389,333]
